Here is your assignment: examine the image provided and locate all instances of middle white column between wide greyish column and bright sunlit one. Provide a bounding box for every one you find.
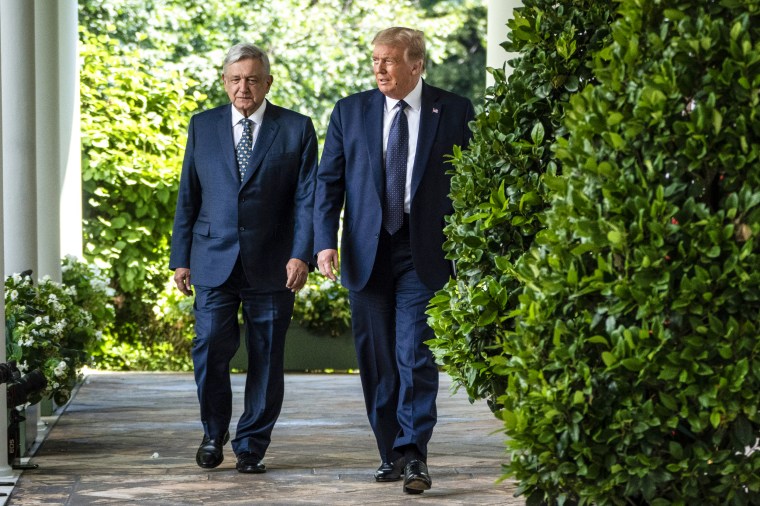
[33,0,60,282]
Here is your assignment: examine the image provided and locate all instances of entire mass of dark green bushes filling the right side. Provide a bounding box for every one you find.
[430,0,760,505]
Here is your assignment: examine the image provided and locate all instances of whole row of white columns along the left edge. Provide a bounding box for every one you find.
[0,0,82,477]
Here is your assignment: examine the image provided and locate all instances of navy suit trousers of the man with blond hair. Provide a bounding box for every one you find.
[349,219,438,462]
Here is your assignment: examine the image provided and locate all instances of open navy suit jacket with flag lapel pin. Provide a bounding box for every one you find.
[314,82,475,290]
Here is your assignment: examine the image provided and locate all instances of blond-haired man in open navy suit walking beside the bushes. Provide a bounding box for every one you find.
[314,28,474,494]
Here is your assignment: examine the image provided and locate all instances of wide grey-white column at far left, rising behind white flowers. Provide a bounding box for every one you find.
[0,0,36,275]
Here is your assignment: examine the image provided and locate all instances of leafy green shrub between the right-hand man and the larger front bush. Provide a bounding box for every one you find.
[429,0,613,410]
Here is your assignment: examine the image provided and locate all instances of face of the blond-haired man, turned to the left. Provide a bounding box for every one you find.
[372,44,422,100]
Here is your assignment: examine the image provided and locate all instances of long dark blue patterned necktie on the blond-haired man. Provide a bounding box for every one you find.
[383,100,409,235]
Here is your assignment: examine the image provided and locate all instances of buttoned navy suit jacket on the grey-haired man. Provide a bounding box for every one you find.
[169,102,317,291]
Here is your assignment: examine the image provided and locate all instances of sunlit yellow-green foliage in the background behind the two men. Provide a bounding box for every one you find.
[79,0,485,368]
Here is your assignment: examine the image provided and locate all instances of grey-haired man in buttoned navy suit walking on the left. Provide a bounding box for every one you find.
[170,44,317,473]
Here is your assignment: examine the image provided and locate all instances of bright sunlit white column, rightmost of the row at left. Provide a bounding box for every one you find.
[56,0,83,258]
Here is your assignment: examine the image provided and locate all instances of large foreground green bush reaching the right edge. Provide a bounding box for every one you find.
[501,0,760,505]
